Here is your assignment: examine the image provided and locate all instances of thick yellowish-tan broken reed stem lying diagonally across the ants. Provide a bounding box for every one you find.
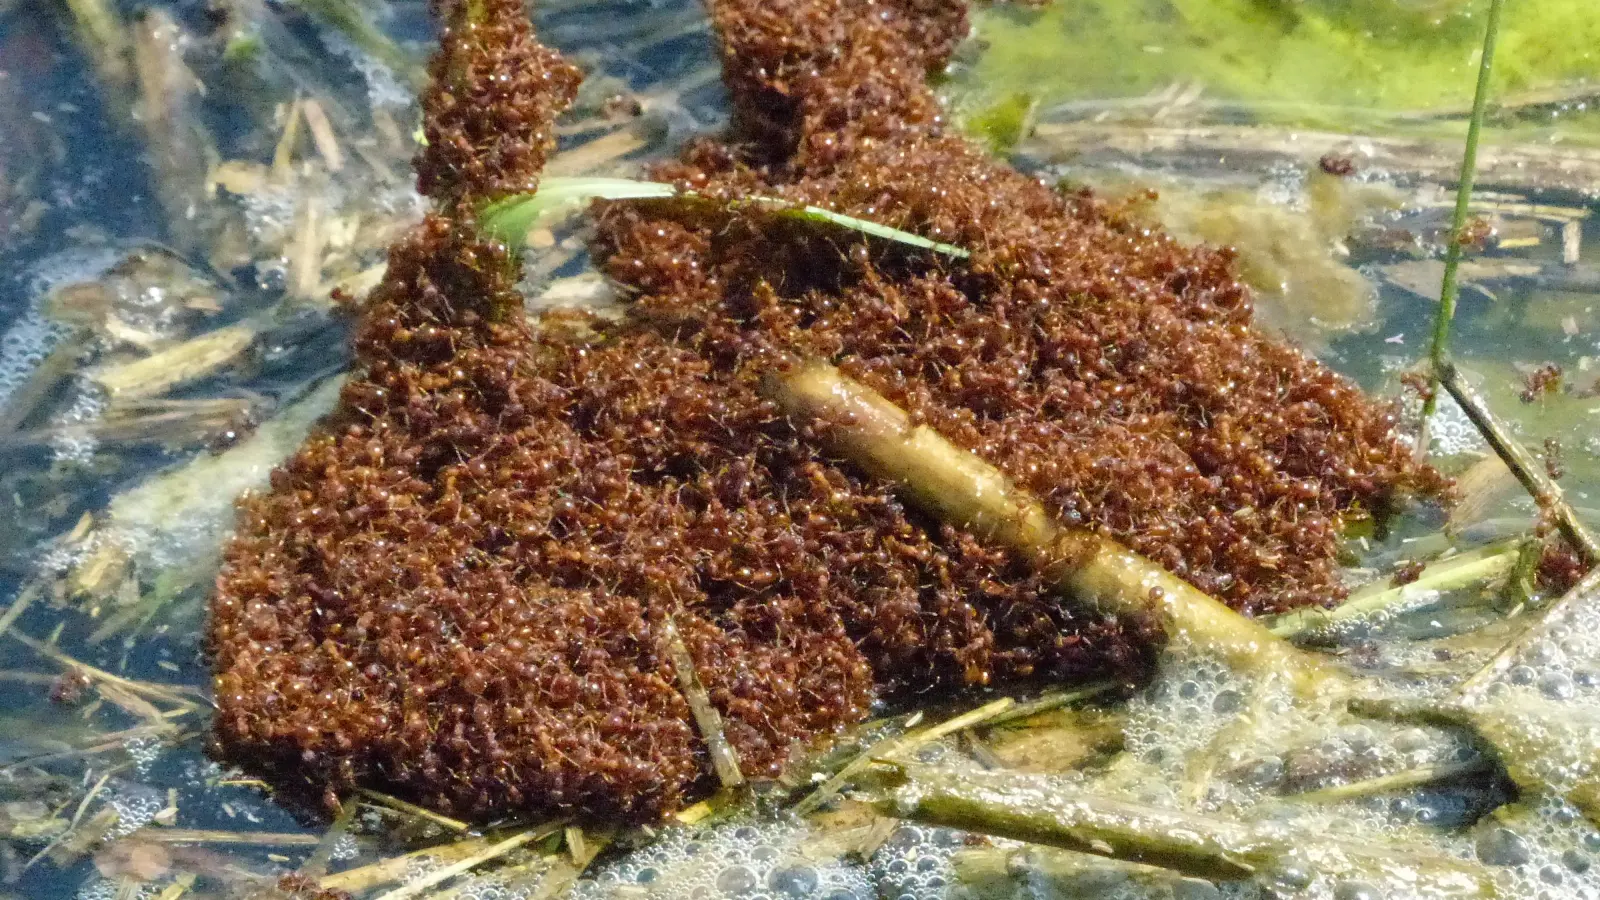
[763,362,1338,689]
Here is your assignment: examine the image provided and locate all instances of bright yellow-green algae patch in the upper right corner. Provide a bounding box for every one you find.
[949,0,1600,138]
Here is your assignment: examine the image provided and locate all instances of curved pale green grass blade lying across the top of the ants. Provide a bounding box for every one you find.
[478,178,970,259]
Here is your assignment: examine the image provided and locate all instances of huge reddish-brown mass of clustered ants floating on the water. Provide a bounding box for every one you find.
[210,0,1445,822]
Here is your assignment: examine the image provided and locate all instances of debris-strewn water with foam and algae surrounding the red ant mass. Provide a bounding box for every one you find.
[0,0,1600,900]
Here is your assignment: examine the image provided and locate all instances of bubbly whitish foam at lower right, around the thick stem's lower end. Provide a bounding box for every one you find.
[885,610,1600,900]
